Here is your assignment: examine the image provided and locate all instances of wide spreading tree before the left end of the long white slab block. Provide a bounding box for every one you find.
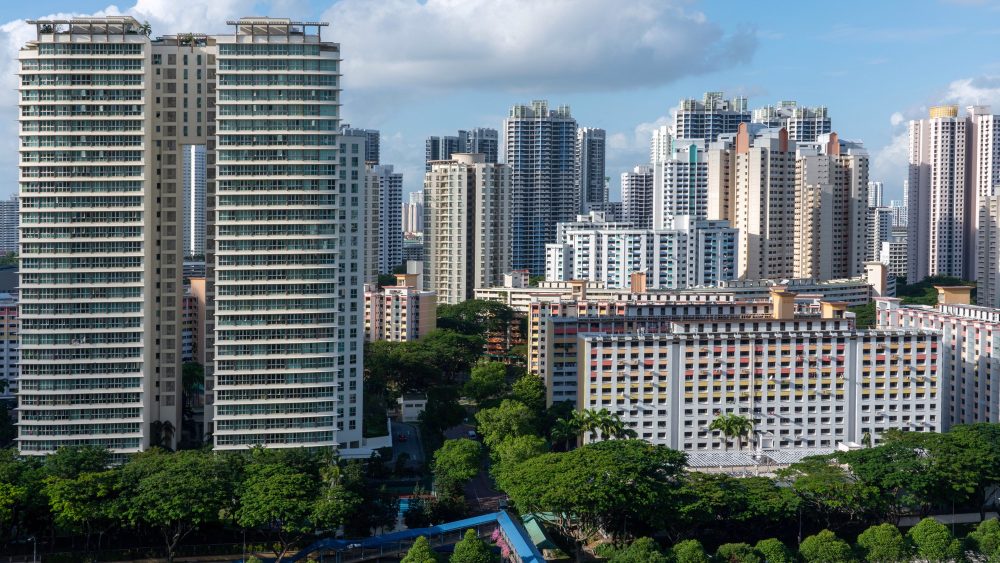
[498,440,686,538]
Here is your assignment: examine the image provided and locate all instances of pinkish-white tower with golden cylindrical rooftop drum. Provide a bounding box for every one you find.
[906,106,974,281]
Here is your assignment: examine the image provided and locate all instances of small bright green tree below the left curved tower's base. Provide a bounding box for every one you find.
[43,471,118,550]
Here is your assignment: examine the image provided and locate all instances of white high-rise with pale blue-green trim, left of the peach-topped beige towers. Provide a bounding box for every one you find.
[653,139,708,229]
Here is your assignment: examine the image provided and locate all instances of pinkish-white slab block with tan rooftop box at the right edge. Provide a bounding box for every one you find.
[877,287,1000,428]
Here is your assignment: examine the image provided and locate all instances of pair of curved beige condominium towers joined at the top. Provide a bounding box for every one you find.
[18,16,364,455]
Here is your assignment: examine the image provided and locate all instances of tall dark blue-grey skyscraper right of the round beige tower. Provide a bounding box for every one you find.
[500,100,580,278]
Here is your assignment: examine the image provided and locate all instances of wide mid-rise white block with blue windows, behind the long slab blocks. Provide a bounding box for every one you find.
[545,213,737,289]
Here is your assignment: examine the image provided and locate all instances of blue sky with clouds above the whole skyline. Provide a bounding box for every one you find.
[0,0,1000,197]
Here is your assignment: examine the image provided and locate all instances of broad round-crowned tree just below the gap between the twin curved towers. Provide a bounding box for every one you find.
[116,450,231,561]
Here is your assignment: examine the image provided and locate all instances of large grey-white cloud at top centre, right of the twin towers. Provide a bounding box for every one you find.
[323,0,757,92]
